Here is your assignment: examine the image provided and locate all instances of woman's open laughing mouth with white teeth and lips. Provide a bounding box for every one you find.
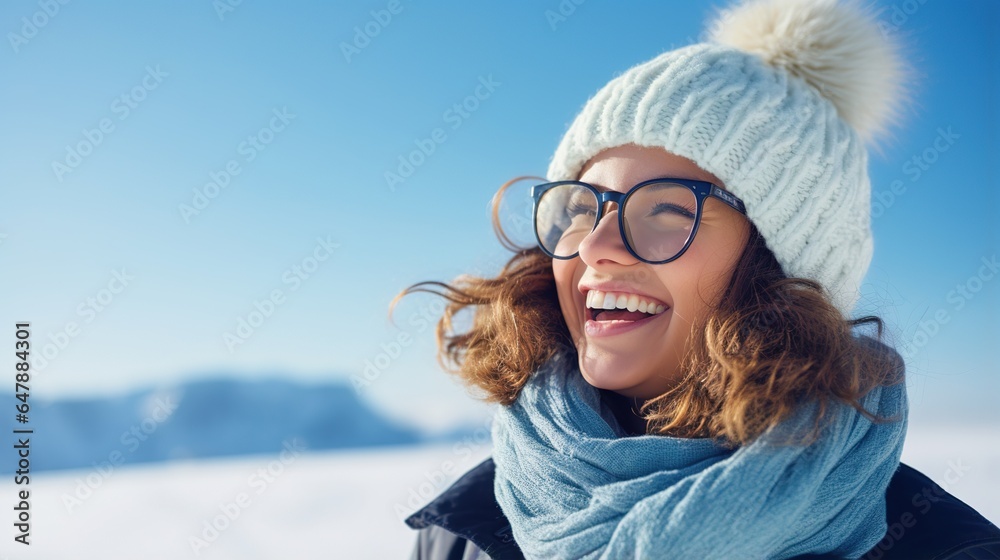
[584,290,670,336]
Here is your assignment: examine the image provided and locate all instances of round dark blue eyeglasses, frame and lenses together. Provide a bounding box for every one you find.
[531,178,746,264]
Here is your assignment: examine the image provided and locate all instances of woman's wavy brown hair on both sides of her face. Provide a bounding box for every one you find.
[389,177,904,445]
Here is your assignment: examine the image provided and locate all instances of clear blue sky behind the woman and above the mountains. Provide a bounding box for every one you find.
[0,0,1000,426]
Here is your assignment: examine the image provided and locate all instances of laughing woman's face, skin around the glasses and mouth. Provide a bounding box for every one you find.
[552,145,749,399]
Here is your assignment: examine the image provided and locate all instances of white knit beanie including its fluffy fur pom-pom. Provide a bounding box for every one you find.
[548,0,908,316]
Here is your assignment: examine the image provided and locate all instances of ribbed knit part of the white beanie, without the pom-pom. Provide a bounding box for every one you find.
[548,44,873,316]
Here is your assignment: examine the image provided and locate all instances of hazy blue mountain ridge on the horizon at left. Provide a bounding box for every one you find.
[0,377,423,473]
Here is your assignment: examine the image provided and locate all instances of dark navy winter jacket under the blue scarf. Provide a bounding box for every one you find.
[406,458,1000,560]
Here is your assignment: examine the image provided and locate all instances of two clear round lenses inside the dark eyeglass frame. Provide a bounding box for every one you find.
[535,183,698,261]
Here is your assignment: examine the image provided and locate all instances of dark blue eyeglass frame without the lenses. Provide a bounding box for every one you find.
[531,177,747,264]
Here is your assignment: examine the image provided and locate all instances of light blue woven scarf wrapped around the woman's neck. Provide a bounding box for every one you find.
[493,344,907,560]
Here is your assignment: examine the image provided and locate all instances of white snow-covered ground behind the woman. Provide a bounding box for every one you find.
[0,427,1000,560]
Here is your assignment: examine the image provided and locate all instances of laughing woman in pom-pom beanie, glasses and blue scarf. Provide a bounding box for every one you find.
[401,0,1000,559]
